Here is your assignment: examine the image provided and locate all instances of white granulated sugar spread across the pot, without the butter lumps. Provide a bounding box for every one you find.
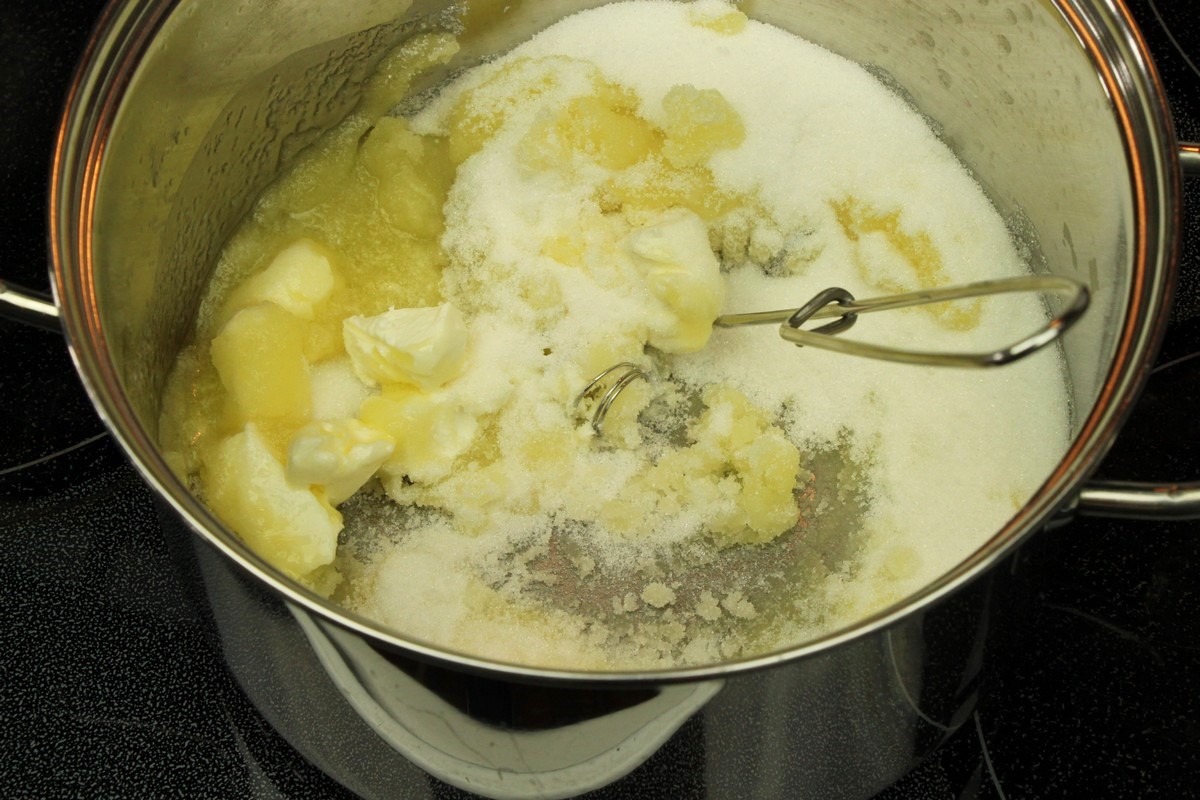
[336,0,1067,668]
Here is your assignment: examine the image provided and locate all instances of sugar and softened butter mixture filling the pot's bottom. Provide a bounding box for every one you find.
[159,0,1068,668]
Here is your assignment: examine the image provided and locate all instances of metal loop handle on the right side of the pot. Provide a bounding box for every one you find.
[1074,142,1200,519]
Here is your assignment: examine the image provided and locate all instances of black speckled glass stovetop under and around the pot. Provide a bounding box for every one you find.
[0,0,1200,800]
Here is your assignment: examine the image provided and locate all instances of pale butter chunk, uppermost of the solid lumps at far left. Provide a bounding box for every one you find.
[227,239,336,319]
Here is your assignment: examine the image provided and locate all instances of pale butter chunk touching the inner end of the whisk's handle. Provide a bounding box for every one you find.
[626,209,725,353]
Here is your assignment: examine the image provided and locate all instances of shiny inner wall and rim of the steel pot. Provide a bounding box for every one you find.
[53,1,1178,678]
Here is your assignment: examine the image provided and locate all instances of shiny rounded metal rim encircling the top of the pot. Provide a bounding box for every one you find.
[49,0,1182,685]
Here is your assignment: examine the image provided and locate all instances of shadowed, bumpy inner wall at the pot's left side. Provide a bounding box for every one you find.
[96,0,432,431]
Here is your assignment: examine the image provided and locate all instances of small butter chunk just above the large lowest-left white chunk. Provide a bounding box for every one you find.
[287,420,396,505]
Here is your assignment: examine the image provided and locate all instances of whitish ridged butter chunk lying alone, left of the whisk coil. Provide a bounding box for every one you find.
[342,303,467,391]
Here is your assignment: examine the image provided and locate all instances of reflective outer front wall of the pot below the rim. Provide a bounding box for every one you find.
[177,513,990,800]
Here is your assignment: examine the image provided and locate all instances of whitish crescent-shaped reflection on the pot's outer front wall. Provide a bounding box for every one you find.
[300,606,722,799]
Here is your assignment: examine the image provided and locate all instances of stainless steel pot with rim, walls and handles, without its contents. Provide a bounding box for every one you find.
[9,0,1200,798]
